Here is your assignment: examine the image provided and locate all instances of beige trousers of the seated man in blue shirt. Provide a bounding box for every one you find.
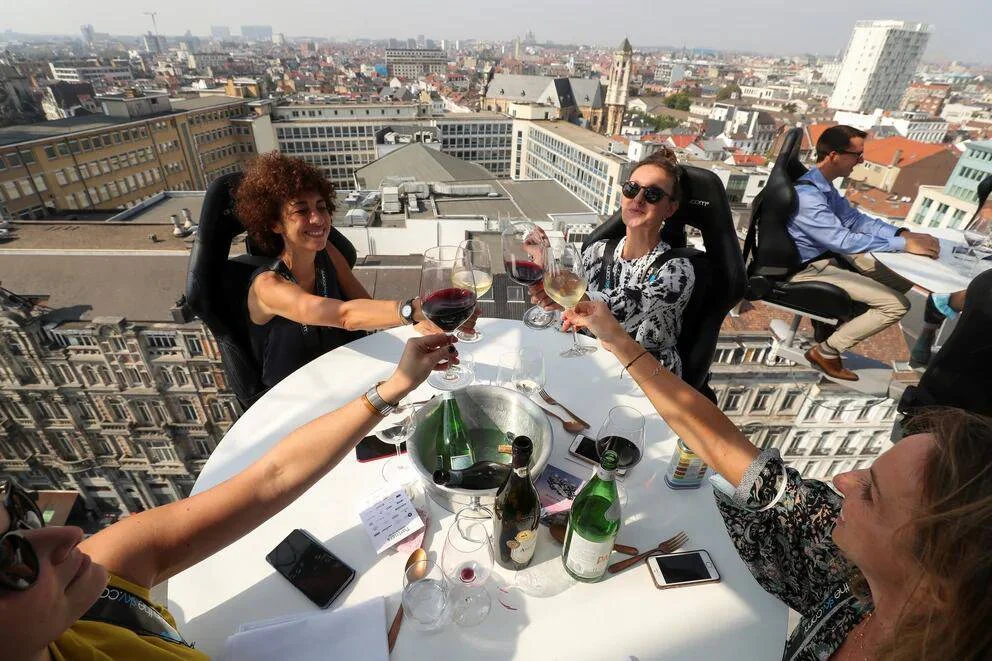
[790,254,913,353]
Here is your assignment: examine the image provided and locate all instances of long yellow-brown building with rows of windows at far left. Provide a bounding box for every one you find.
[0,95,255,218]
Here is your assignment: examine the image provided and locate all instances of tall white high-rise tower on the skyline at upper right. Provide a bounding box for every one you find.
[829,21,930,112]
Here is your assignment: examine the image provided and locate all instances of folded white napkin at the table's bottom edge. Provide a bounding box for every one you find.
[218,597,389,661]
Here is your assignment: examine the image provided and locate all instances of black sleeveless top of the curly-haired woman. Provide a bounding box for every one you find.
[246,250,366,388]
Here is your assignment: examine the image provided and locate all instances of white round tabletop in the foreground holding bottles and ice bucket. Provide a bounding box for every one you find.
[169,319,787,661]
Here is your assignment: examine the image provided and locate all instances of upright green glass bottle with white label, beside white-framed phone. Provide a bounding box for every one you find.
[561,450,620,583]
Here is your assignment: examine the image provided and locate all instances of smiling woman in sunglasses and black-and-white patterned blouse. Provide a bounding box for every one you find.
[531,149,695,376]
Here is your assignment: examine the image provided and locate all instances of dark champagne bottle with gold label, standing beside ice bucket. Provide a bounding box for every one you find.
[493,436,541,570]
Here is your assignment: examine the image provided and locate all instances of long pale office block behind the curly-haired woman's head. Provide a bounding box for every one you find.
[250,102,512,189]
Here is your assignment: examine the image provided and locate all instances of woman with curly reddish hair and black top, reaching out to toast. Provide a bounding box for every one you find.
[235,152,460,387]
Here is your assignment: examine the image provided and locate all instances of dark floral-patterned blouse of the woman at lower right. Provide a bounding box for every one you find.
[715,450,872,661]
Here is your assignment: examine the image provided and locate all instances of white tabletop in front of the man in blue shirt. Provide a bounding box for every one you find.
[871,228,992,294]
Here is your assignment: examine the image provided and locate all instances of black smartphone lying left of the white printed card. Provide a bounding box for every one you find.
[265,528,355,608]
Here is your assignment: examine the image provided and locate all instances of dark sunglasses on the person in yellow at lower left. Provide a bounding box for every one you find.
[0,478,45,590]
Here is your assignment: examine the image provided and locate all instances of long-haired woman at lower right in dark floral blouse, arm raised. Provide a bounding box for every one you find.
[565,302,992,661]
